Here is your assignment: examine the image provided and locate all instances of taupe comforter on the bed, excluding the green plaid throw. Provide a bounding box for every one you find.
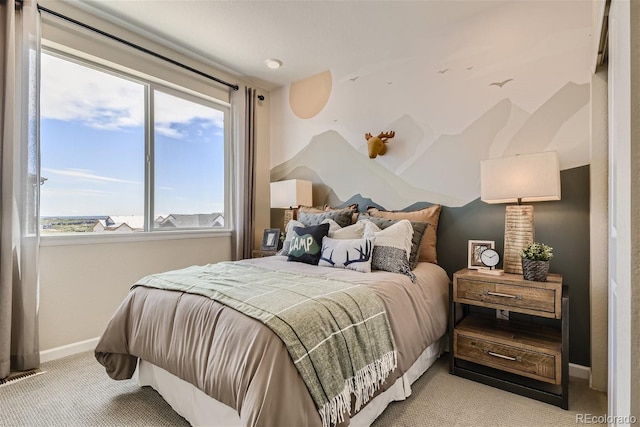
[96,257,449,426]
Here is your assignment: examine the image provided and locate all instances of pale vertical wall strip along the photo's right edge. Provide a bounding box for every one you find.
[608,0,640,425]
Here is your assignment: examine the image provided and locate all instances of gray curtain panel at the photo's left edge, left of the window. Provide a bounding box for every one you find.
[0,0,40,378]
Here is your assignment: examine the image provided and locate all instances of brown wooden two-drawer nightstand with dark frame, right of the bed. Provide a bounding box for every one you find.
[449,269,569,409]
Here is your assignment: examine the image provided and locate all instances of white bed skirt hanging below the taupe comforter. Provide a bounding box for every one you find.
[138,335,446,427]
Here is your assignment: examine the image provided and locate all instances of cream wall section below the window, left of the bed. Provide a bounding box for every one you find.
[40,236,231,351]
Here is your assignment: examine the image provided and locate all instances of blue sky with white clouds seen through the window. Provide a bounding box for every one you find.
[40,53,224,217]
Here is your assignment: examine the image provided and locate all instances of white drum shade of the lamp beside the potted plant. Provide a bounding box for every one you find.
[480,151,560,203]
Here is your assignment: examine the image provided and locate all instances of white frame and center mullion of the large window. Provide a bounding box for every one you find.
[38,43,234,246]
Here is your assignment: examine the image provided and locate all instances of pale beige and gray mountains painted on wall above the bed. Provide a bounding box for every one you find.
[271,82,589,209]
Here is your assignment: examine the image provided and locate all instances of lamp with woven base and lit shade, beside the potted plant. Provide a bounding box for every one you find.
[480,151,560,274]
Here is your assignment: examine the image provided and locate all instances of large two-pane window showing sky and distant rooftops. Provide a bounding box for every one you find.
[40,52,229,235]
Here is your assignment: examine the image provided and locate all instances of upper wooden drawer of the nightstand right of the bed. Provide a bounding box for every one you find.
[454,277,562,318]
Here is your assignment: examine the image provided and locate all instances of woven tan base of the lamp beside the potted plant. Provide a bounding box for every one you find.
[503,205,534,274]
